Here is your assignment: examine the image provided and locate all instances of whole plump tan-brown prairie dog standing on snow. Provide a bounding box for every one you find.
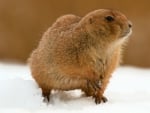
[29,9,132,104]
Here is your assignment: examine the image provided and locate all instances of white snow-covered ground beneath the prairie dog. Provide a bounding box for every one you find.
[0,63,150,113]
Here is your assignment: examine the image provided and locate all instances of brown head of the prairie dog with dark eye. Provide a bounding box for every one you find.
[80,9,132,42]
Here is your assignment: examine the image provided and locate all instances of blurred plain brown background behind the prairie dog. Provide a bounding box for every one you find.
[0,0,150,67]
